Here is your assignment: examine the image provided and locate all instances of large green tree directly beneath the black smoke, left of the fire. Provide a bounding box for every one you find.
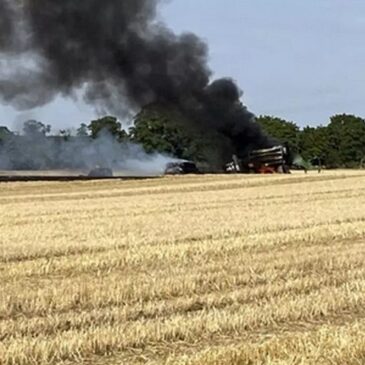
[130,104,239,171]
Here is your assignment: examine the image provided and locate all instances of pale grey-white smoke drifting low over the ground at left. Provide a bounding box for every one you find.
[0,133,178,175]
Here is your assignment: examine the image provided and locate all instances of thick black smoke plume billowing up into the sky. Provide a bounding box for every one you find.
[0,0,268,162]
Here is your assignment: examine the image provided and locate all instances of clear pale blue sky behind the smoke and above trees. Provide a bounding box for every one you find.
[0,0,365,130]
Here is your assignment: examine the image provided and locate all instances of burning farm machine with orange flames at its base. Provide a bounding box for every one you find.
[226,146,290,174]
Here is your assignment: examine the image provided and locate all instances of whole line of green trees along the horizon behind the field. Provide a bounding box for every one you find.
[0,107,365,168]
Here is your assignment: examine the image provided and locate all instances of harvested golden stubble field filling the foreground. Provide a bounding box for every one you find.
[0,171,365,365]
